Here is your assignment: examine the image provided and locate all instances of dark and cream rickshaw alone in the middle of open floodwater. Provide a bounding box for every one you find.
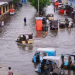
[16,33,33,45]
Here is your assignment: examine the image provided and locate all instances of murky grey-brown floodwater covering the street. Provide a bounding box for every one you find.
[0,3,75,75]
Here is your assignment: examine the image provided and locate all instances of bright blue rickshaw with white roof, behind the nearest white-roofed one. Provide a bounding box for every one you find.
[32,48,56,63]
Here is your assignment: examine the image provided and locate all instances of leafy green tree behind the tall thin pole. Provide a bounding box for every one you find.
[29,0,50,14]
